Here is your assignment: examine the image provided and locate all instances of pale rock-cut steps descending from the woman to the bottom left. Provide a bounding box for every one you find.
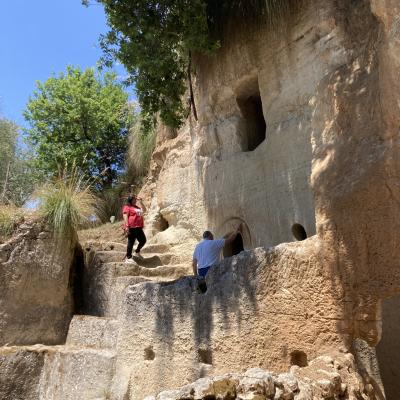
[0,236,190,400]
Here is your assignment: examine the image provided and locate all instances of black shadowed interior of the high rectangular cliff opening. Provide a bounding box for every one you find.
[236,89,267,151]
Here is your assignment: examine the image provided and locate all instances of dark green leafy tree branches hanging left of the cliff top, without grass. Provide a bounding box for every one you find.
[92,0,216,127]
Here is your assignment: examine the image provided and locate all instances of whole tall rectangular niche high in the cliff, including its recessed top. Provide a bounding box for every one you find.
[236,77,267,151]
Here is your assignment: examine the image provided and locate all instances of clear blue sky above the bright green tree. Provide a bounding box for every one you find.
[0,0,129,130]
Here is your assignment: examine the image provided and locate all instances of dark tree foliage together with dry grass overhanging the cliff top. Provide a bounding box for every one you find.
[82,0,293,128]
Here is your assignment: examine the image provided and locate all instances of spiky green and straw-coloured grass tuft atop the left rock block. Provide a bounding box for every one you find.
[35,166,99,235]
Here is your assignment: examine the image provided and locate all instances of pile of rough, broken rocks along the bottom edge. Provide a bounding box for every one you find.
[145,354,379,400]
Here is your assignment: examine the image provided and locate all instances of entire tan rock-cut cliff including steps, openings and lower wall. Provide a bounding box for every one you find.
[0,0,400,400]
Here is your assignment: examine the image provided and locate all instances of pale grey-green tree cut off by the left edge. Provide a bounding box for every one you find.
[0,118,37,206]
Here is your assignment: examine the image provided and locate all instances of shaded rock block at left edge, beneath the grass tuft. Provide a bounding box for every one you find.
[0,222,75,346]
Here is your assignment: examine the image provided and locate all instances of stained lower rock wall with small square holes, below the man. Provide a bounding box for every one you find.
[113,239,351,399]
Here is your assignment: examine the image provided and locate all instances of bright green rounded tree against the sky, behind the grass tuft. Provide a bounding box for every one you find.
[24,66,131,189]
